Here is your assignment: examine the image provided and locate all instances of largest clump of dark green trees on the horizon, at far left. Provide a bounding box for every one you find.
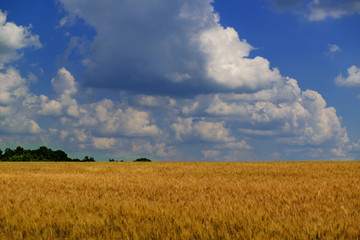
[0,146,95,162]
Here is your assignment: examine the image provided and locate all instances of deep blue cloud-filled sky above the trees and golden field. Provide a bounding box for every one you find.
[0,0,360,161]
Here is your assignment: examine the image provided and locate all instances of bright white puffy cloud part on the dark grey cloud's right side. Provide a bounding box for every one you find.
[200,26,281,90]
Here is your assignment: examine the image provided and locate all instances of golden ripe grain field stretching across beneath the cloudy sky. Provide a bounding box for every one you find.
[0,162,360,239]
